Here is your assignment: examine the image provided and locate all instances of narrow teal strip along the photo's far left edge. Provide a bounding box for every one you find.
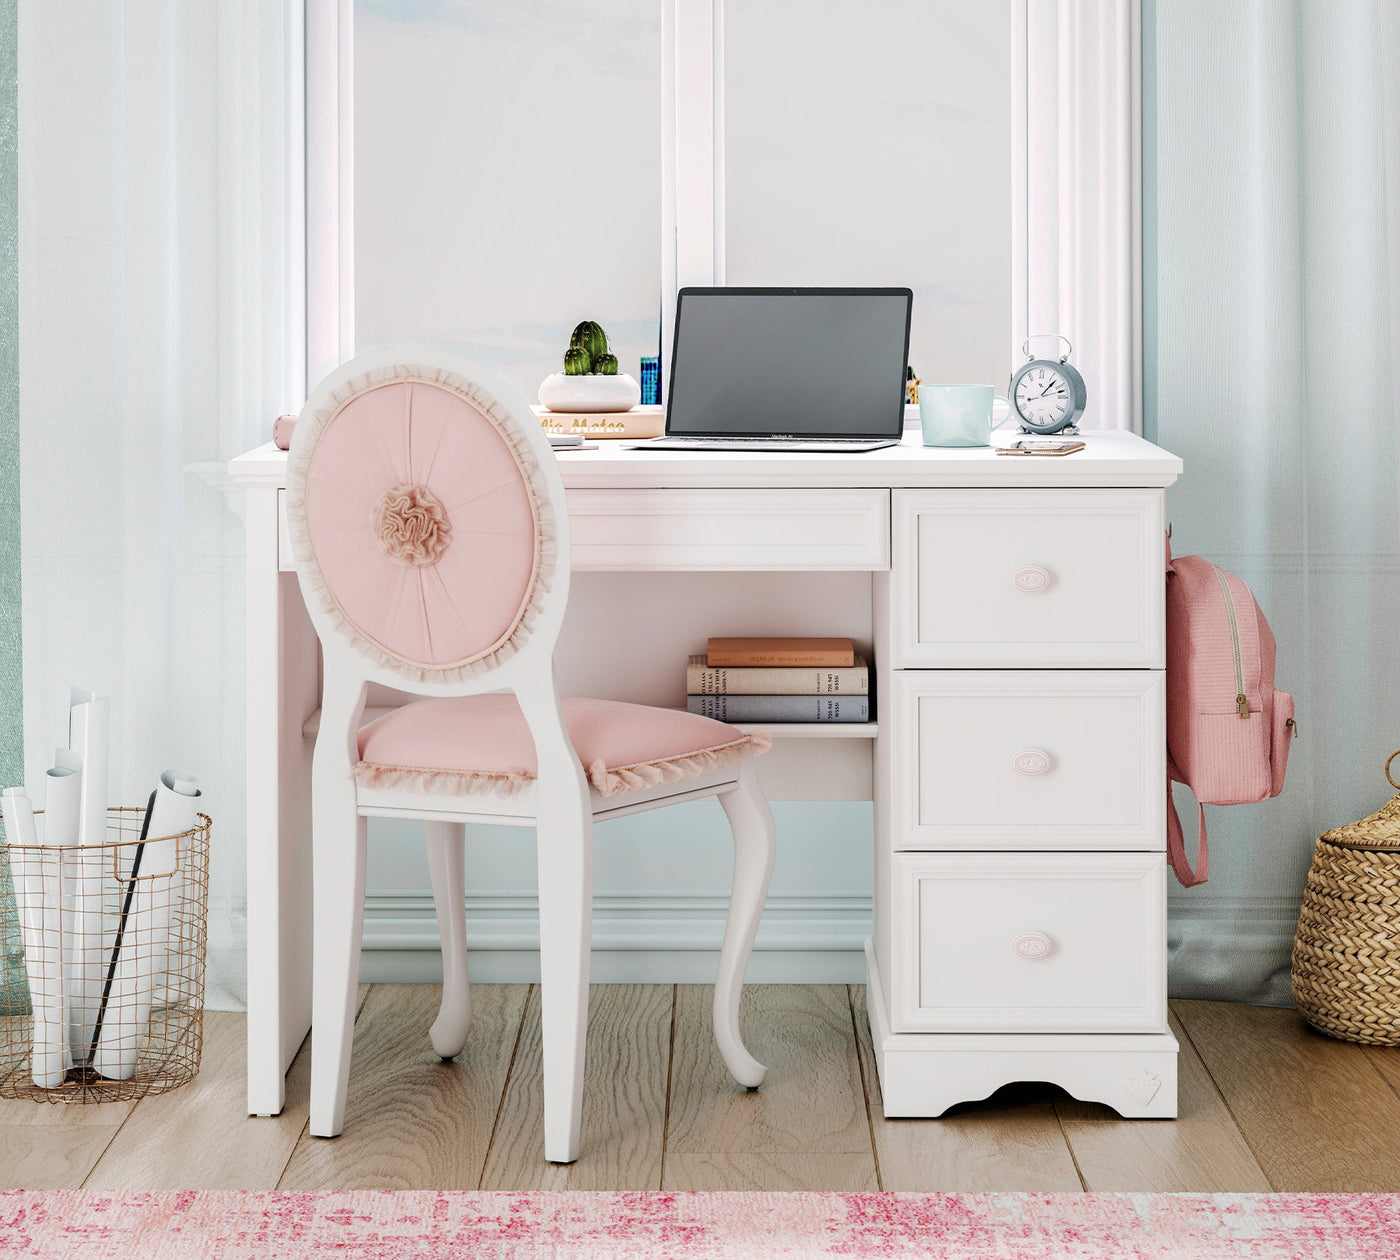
[0,0,24,1014]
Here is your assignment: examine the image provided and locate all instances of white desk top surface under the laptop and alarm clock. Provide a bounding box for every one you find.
[228,428,1182,490]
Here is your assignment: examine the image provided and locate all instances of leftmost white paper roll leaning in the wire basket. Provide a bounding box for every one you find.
[0,788,71,1089]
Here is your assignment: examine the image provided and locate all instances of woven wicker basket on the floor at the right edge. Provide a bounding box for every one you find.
[1292,752,1400,1046]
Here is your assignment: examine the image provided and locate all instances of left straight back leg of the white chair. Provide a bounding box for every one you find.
[311,776,365,1137]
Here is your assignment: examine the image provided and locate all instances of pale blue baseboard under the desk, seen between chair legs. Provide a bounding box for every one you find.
[360,890,872,984]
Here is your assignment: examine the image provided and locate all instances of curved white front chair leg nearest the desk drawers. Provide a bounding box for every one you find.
[714,762,777,1089]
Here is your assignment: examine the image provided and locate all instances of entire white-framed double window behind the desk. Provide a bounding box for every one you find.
[322,0,1141,428]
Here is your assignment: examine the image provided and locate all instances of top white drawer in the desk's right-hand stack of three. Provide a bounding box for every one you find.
[892,490,1166,669]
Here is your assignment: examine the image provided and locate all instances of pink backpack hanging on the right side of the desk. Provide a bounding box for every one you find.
[1166,542,1298,888]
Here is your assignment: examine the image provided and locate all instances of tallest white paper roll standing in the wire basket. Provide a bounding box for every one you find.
[60,687,111,1063]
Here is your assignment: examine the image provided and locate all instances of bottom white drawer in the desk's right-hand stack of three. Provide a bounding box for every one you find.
[895,853,1166,1033]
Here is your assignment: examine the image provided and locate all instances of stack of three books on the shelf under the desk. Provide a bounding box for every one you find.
[686,638,871,722]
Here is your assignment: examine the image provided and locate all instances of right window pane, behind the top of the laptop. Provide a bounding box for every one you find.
[724,0,1011,385]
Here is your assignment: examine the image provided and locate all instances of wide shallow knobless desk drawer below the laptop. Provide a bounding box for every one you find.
[568,489,889,571]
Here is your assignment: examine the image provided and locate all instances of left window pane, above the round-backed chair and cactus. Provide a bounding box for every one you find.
[354,0,661,402]
